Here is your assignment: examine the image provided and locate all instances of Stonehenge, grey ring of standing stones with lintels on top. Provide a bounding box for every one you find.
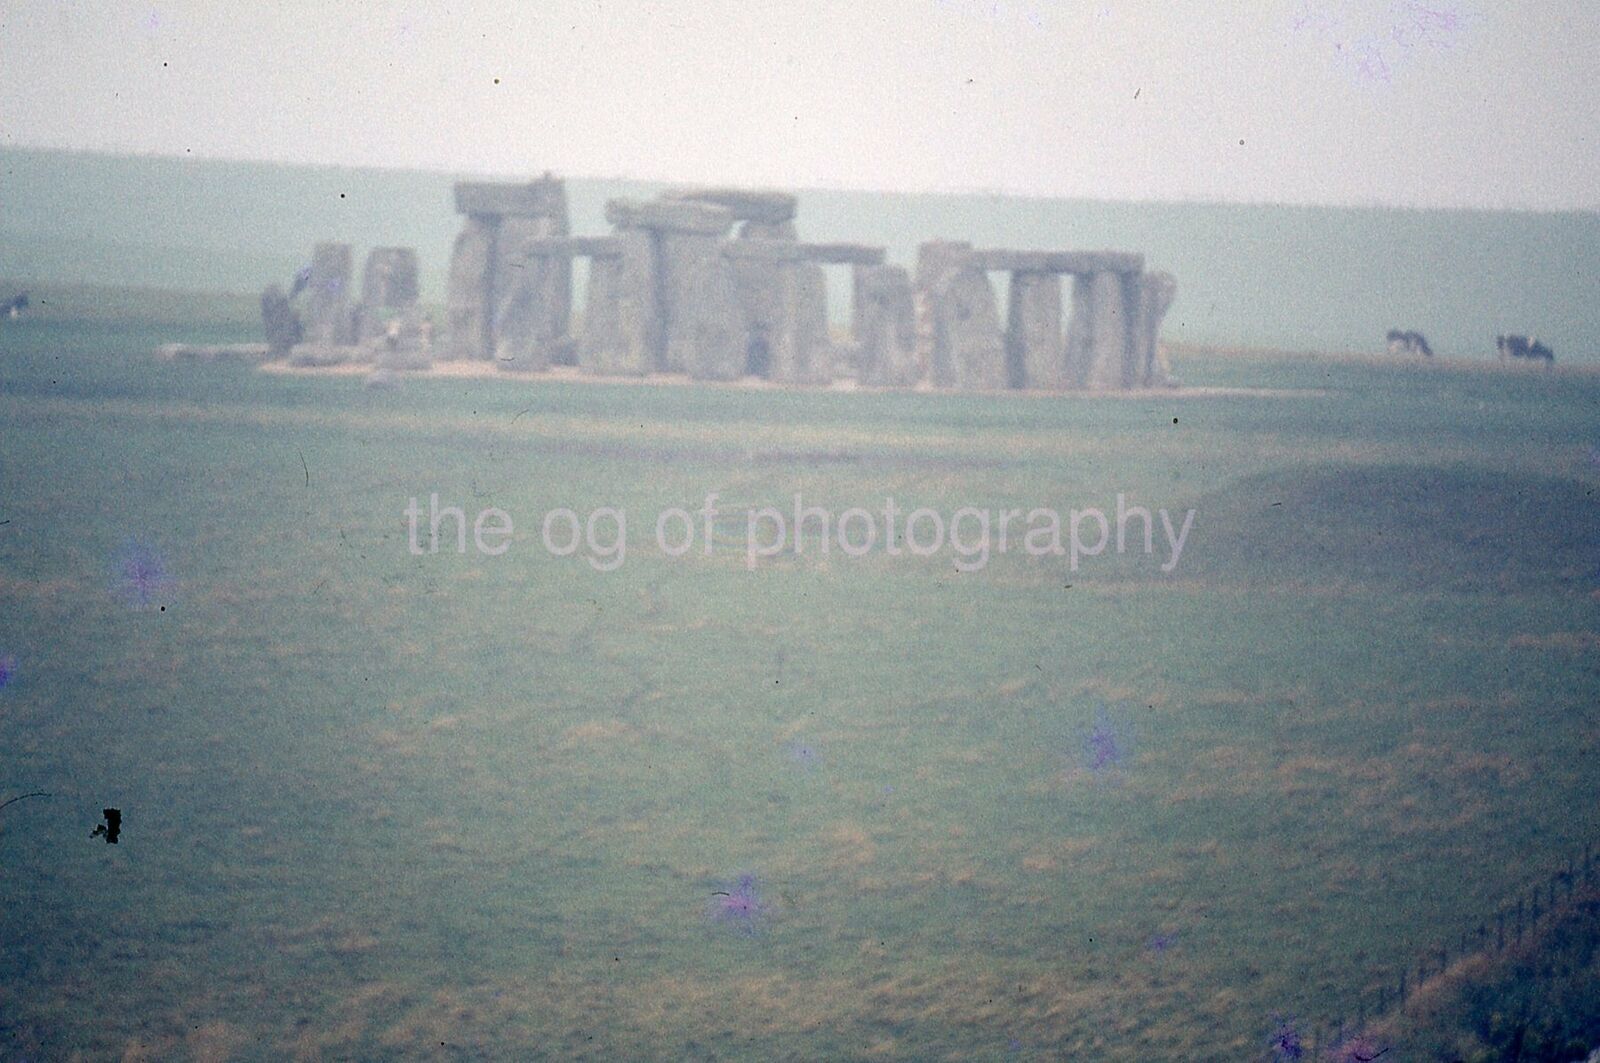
[261,173,1178,391]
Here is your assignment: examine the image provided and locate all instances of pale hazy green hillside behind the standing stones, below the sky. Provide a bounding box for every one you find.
[0,147,1600,362]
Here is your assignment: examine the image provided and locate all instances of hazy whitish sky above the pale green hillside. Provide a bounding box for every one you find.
[0,0,1600,210]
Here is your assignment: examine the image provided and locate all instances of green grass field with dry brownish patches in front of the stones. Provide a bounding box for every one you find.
[0,320,1600,1060]
